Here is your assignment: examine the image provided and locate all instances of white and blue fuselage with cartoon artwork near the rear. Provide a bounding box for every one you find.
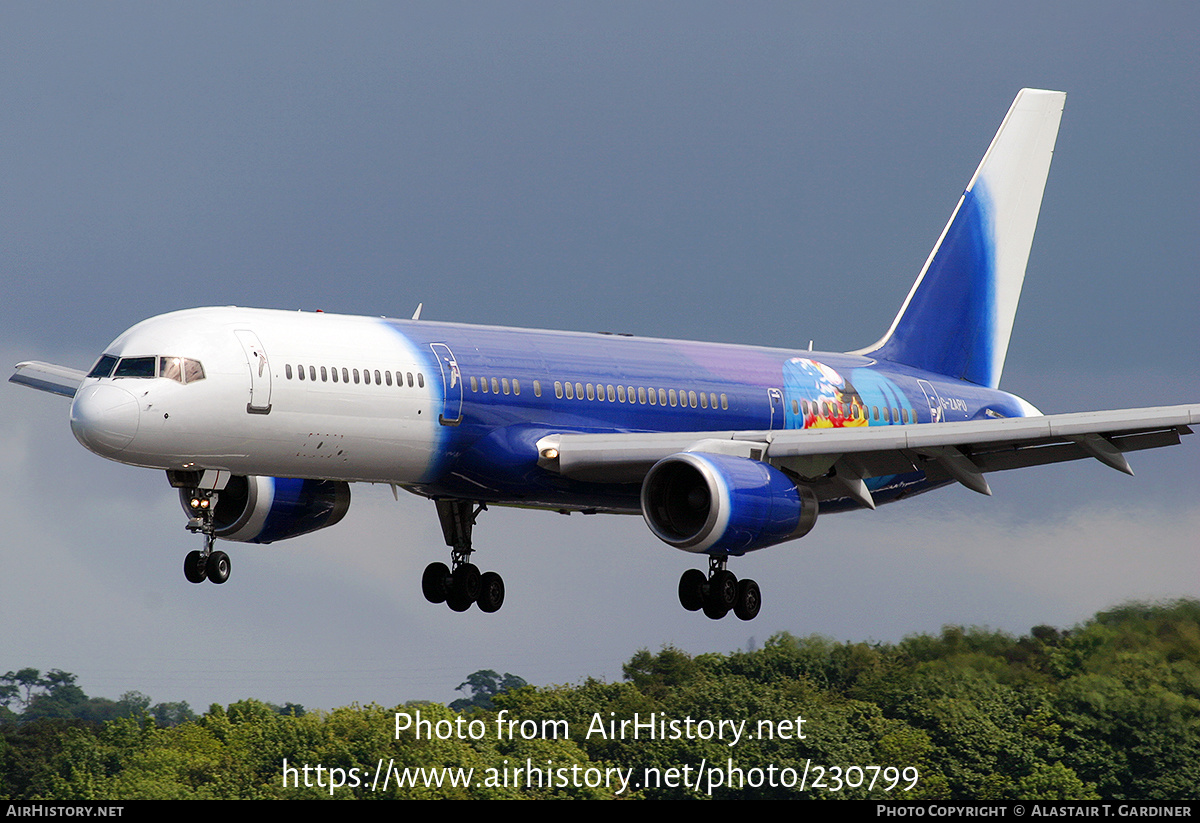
[71,307,1031,513]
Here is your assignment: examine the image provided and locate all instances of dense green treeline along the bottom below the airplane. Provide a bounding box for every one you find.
[0,600,1200,800]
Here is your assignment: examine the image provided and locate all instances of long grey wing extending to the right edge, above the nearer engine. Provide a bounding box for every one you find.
[538,406,1200,507]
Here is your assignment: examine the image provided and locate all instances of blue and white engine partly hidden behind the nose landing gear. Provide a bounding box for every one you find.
[179,475,350,543]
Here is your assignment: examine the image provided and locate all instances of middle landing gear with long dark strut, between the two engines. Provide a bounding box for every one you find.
[421,500,504,612]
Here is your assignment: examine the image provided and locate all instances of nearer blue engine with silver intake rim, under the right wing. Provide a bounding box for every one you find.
[642,451,817,554]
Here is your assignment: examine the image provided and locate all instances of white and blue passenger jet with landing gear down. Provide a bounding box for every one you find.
[10,89,1200,620]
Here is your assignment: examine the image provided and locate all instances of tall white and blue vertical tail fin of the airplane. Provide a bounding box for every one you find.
[858,89,1067,389]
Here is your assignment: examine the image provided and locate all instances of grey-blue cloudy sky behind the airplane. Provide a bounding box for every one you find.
[0,2,1200,708]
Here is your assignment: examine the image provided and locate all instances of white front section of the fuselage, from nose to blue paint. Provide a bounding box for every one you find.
[71,307,438,483]
